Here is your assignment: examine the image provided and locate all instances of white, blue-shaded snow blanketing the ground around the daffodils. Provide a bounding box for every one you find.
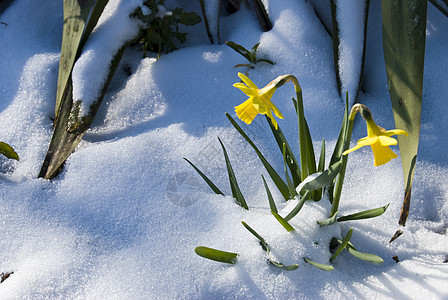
[0,0,448,299]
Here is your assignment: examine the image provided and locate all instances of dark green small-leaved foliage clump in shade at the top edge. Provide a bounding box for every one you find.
[131,0,202,57]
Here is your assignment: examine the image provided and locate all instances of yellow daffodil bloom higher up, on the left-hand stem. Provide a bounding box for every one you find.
[233,73,283,129]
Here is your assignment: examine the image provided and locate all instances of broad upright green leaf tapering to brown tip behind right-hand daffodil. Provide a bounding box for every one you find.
[381,0,427,226]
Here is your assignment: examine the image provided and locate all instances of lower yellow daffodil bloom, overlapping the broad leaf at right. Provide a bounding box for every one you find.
[342,119,408,166]
